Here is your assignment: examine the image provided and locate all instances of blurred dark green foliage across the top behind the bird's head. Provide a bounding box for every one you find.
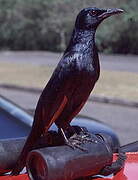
[0,0,138,54]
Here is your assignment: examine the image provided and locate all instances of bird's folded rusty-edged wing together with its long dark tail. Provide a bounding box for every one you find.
[12,56,78,175]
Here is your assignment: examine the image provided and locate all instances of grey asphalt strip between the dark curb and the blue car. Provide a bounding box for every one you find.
[0,88,138,145]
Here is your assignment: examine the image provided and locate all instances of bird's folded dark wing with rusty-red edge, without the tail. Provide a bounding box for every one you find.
[34,52,76,131]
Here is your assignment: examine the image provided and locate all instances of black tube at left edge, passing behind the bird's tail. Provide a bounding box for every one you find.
[0,131,61,175]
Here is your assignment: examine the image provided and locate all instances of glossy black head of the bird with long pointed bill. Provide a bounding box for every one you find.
[75,7,123,30]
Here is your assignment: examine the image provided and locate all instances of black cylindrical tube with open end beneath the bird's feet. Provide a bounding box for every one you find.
[26,135,113,180]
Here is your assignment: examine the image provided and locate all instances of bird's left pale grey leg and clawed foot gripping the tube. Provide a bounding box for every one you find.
[59,128,87,151]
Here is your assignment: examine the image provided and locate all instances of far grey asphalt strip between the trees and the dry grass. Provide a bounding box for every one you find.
[0,51,138,73]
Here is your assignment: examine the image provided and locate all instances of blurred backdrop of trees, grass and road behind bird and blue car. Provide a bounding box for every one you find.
[0,0,138,144]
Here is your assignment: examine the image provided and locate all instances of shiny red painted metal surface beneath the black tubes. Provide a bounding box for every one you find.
[0,153,138,180]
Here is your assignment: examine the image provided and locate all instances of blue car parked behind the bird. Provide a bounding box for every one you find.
[0,96,118,144]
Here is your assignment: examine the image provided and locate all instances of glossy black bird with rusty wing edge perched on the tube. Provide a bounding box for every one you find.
[12,7,123,175]
